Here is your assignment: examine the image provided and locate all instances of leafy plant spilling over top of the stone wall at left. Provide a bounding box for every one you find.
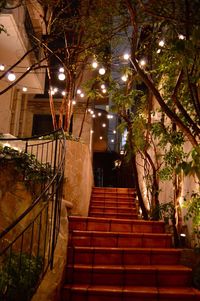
[0,145,52,182]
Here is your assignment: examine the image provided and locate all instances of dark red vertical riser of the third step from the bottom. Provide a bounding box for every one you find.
[68,248,180,266]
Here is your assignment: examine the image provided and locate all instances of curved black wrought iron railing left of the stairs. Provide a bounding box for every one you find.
[0,130,66,301]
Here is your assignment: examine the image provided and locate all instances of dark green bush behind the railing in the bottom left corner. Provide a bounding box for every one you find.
[0,253,43,301]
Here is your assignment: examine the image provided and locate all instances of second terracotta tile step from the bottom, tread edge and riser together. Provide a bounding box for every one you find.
[66,264,192,287]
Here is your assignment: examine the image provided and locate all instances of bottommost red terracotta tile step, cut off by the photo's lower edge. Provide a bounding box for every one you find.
[62,284,200,301]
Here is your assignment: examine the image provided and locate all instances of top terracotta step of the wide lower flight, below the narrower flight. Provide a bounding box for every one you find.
[69,216,165,233]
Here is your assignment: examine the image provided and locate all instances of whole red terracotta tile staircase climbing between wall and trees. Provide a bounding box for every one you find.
[62,188,200,301]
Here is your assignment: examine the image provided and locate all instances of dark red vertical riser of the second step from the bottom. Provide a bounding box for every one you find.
[66,268,191,287]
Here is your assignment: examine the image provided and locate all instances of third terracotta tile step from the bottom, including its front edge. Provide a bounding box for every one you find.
[68,247,181,266]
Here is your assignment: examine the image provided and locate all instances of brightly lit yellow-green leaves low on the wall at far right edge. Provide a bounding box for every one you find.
[184,193,200,249]
